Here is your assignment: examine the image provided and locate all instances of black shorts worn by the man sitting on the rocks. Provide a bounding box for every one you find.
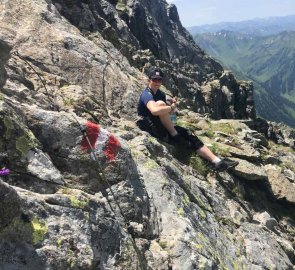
[136,116,204,150]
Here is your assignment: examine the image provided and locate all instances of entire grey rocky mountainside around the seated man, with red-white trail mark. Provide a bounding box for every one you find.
[0,0,295,270]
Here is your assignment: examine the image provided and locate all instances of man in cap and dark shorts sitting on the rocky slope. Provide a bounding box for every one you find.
[137,68,238,171]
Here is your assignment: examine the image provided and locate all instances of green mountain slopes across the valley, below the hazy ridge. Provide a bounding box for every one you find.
[194,31,295,127]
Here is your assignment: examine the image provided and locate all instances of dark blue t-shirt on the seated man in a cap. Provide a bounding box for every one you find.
[137,87,166,117]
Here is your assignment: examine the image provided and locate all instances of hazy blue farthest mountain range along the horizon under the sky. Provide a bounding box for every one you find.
[188,15,295,36]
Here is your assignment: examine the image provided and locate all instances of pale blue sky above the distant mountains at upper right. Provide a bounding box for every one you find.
[166,0,295,27]
